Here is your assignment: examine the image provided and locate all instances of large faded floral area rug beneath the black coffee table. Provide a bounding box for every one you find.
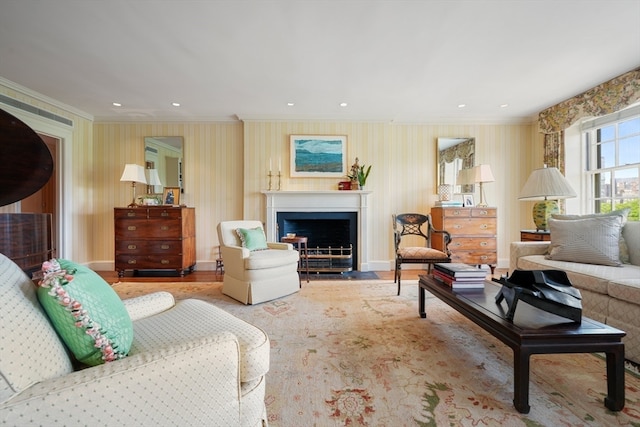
[114,280,640,427]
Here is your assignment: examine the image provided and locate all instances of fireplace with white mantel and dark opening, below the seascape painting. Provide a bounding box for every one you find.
[263,190,371,271]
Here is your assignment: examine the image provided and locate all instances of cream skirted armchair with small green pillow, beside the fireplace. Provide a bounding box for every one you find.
[218,221,300,304]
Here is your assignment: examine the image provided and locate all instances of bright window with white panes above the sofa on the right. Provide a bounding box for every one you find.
[582,107,640,221]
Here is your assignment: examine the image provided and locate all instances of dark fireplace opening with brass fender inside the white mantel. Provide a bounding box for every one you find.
[277,212,358,272]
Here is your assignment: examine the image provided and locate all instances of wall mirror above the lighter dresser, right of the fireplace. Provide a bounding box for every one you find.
[437,138,476,194]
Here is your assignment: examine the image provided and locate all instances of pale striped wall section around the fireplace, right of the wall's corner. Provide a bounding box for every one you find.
[242,121,536,265]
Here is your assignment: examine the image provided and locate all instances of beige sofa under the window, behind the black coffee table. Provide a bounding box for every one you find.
[509,221,640,363]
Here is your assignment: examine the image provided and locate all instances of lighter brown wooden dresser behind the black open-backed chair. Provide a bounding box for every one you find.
[431,207,498,274]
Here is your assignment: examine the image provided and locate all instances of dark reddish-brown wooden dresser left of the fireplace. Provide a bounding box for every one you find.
[113,206,196,277]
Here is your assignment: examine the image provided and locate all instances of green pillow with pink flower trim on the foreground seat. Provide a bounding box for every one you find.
[38,259,133,366]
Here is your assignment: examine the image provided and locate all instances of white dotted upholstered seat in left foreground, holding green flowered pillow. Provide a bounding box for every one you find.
[0,254,270,427]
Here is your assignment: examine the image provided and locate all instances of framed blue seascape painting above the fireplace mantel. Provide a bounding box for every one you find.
[291,135,347,178]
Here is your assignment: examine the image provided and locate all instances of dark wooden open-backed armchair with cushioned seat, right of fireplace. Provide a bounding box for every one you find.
[393,213,451,295]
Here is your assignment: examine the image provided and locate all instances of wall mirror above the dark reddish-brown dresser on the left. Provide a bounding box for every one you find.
[144,136,184,194]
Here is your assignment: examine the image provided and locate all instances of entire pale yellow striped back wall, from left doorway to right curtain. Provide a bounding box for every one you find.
[0,81,542,269]
